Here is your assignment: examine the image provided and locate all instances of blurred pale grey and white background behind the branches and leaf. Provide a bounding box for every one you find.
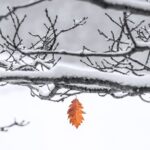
[0,0,150,150]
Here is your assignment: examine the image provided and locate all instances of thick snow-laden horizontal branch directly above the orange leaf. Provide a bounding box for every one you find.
[0,65,150,96]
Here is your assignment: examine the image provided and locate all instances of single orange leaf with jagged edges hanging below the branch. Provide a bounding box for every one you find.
[67,99,84,128]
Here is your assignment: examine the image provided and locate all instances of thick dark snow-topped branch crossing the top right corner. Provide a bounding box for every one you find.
[80,0,150,16]
